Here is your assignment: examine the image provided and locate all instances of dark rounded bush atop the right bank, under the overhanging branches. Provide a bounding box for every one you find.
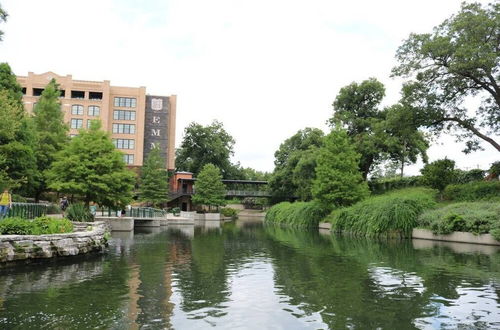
[420,158,456,192]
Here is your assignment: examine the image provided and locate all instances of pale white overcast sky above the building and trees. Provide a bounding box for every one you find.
[0,0,498,174]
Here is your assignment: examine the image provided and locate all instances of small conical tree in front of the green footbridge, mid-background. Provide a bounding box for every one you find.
[193,164,226,209]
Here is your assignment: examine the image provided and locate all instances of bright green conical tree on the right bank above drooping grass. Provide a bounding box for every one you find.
[312,125,369,208]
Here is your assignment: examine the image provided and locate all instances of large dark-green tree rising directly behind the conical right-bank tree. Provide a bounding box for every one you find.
[329,78,428,179]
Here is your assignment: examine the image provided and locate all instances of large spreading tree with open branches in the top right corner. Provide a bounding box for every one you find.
[393,2,500,152]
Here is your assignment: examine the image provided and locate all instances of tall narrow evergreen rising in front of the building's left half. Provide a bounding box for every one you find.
[33,79,69,200]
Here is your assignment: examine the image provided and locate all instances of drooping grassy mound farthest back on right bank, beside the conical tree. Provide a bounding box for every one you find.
[264,201,328,228]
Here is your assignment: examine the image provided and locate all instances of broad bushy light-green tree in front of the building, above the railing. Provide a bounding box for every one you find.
[47,120,135,207]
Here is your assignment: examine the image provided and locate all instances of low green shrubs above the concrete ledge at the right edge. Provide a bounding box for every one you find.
[418,202,500,240]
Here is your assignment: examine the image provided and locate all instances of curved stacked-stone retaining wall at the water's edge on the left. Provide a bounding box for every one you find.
[0,221,109,263]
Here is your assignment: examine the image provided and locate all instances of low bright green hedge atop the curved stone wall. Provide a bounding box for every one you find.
[0,216,73,235]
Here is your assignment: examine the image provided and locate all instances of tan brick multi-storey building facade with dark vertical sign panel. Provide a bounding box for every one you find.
[17,72,177,170]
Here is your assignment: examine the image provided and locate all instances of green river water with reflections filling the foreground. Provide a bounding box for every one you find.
[0,220,500,329]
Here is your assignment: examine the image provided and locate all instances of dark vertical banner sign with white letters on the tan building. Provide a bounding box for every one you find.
[144,95,170,168]
